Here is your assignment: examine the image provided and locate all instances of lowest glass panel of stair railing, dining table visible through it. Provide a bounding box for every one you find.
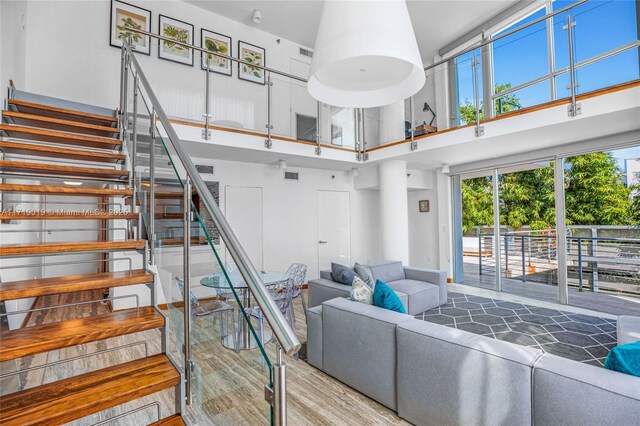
[190,200,275,425]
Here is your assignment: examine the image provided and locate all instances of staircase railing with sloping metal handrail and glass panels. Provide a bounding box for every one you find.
[119,33,301,425]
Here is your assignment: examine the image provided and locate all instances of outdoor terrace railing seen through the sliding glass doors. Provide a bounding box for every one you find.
[464,226,640,296]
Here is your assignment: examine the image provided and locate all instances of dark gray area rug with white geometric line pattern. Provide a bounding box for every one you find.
[416,292,616,366]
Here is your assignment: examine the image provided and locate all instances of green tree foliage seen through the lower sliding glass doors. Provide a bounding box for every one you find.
[462,152,640,232]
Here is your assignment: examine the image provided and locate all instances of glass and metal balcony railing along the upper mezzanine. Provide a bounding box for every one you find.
[119,0,640,161]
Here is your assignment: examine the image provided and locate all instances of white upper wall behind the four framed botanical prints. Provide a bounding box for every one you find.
[13,0,310,135]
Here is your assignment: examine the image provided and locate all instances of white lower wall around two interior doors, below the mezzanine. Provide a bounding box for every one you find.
[194,158,381,279]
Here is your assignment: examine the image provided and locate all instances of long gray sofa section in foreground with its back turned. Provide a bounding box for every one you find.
[307,298,640,426]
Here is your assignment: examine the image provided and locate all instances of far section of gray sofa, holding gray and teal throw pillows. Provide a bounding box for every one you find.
[308,261,447,315]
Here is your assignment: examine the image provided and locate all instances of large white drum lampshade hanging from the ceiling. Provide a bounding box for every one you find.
[307,0,425,108]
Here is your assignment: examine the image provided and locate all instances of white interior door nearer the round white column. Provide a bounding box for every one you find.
[318,191,351,271]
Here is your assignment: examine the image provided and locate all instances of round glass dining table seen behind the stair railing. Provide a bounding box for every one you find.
[200,265,289,350]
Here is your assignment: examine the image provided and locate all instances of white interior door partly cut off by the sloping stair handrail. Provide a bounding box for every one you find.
[225,186,264,269]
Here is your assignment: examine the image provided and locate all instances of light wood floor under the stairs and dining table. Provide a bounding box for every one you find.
[2,292,408,426]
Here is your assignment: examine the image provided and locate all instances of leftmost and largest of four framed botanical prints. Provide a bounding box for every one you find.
[109,0,151,55]
